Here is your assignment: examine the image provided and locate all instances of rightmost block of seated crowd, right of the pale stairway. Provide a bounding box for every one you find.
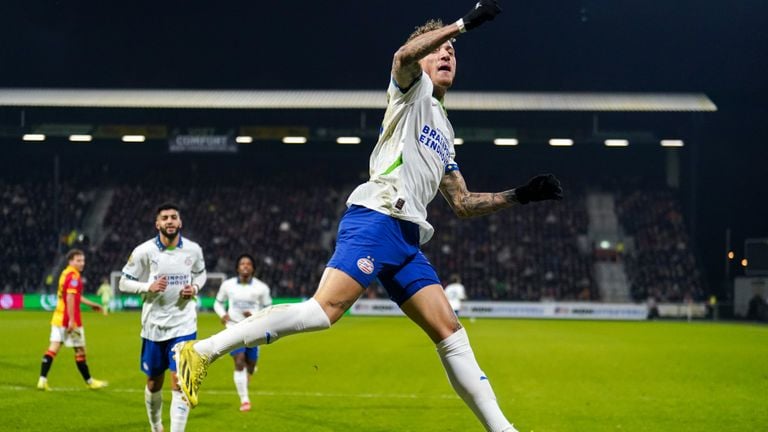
[616,189,704,302]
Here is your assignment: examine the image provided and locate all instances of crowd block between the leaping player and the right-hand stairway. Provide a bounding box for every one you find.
[424,192,598,301]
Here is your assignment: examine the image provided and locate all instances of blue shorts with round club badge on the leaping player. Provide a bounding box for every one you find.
[327,205,440,306]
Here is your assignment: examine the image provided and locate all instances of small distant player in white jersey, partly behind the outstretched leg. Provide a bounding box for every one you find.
[213,254,272,411]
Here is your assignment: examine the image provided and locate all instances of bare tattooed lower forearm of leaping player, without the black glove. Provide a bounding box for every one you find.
[440,170,518,218]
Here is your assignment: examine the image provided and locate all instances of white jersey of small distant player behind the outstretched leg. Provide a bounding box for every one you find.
[215,277,272,327]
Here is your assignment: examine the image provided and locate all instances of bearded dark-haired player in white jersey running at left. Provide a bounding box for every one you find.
[119,203,206,432]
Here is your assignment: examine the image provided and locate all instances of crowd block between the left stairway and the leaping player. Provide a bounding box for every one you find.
[86,177,342,297]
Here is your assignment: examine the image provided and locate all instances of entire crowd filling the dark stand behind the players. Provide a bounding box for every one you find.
[0,164,703,301]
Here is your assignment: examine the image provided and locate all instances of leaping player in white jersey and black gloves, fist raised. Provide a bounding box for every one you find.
[174,0,562,432]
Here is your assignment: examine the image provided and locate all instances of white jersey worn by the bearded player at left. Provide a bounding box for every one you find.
[123,236,205,342]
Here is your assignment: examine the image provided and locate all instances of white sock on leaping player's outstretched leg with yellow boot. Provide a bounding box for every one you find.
[194,298,331,361]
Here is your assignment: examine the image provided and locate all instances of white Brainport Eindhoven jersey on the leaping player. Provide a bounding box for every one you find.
[347,72,458,244]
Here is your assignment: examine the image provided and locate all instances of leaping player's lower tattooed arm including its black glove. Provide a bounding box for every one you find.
[440,170,563,218]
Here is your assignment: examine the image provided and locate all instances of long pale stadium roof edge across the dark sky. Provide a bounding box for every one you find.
[0,88,717,112]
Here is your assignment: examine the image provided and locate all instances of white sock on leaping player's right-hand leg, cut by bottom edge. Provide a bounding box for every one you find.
[437,328,515,432]
